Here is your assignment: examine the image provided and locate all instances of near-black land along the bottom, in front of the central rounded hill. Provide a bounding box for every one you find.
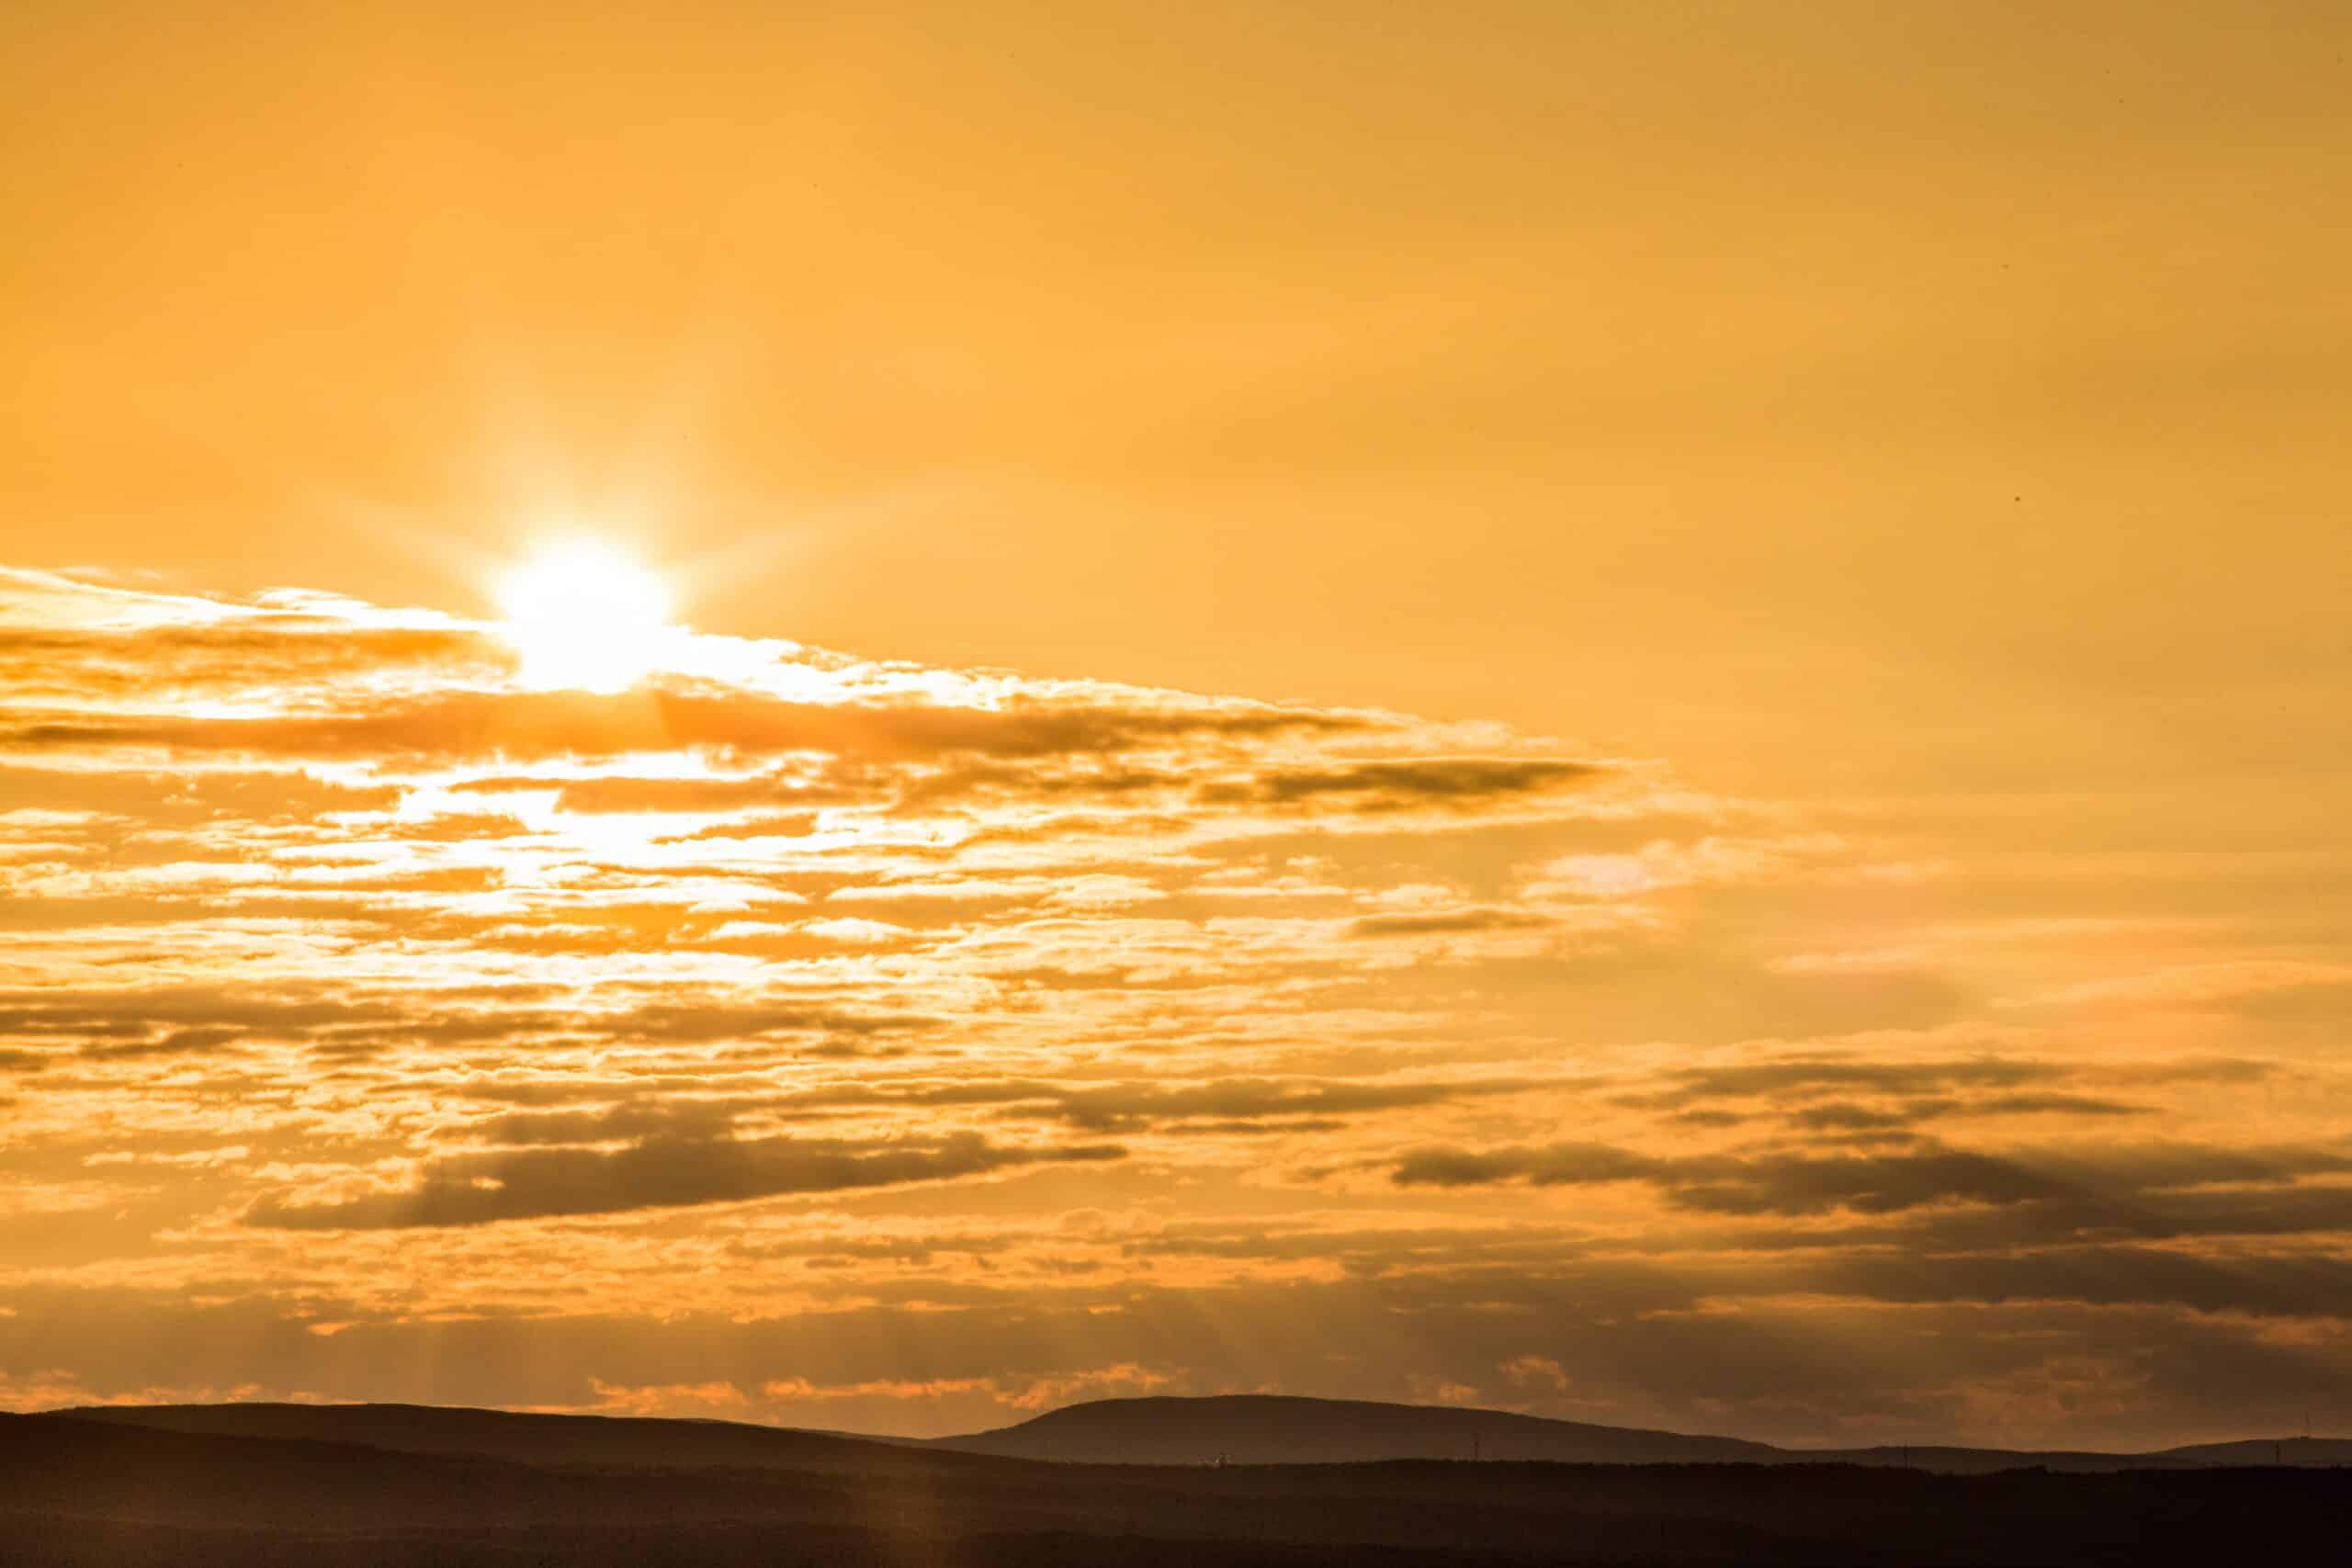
[0,1401,2352,1568]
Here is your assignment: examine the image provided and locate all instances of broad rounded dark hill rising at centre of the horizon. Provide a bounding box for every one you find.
[932,1394,1785,1464]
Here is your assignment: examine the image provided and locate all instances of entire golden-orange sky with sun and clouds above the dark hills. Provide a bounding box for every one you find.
[0,0,2352,1446]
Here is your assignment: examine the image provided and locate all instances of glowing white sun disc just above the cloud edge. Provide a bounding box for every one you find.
[499,538,673,696]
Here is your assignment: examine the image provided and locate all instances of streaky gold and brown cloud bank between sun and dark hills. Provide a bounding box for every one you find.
[0,571,2352,1443]
